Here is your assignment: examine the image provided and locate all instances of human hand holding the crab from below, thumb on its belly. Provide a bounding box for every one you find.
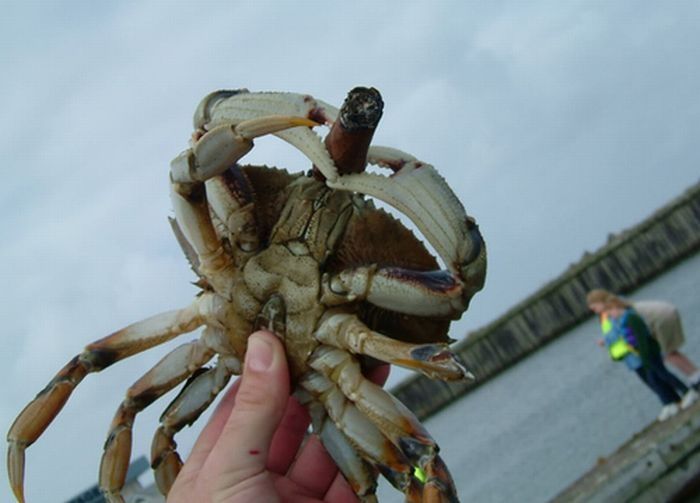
[168,332,388,503]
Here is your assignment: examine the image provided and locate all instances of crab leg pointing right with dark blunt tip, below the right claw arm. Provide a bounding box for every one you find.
[315,313,473,380]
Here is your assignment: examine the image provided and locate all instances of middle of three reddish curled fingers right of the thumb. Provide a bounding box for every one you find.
[289,435,338,498]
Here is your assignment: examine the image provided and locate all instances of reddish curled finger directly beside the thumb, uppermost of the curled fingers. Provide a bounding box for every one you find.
[267,397,311,475]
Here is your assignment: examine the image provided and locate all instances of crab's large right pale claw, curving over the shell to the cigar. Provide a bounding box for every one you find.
[326,147,486,301]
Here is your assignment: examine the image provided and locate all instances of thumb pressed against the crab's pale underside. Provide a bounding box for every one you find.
[207,332,289,492]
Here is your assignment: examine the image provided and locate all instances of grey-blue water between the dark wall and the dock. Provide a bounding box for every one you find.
[378,254,700,503]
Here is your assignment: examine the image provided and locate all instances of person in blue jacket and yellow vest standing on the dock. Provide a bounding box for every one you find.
[601,296,700,421]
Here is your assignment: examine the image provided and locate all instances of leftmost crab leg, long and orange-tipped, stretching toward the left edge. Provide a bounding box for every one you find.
[7,294,215,501]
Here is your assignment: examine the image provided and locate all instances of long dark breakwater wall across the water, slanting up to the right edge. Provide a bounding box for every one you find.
[392,182,700,419]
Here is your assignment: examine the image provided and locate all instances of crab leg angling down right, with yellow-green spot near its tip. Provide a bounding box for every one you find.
[309,346,457,501]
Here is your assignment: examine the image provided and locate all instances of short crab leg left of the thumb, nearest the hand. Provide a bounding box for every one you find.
[151,356,240,495]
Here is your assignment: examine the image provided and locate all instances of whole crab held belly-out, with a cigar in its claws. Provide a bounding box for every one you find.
[7,88,486,501]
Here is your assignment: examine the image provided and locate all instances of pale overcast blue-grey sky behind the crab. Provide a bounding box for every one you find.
[0,0,700,501]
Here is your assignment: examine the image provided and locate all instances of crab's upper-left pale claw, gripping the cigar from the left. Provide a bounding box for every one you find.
[194,89,338,180]
